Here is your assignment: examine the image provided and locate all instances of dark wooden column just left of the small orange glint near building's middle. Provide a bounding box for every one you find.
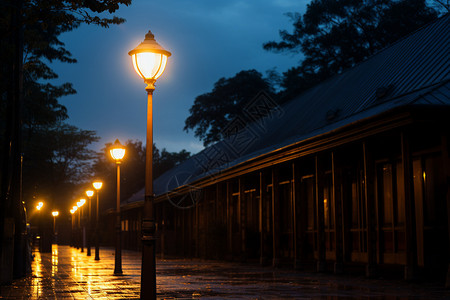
[315,156,326,272]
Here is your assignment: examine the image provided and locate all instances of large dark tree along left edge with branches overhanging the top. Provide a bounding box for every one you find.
[0,0,131,276]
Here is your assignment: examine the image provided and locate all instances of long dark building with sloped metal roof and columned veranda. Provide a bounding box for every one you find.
[122,15,450,279]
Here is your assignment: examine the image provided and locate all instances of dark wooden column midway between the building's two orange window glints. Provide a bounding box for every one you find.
[363,142,377,277]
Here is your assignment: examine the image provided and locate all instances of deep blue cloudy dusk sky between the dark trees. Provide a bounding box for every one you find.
[52,0,310,153]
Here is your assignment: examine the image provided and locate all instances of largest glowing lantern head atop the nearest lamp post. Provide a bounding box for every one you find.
[128,30,172,90]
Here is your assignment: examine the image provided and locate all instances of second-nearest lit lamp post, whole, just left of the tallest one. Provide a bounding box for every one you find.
[109,140,125,275]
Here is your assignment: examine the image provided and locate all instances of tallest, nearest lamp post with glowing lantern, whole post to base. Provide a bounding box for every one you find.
[128,31,171,299]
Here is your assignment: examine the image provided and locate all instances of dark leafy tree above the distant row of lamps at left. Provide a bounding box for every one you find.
[23,123,98,209]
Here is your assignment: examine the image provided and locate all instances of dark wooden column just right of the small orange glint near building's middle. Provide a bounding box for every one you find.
[331,151,344,274]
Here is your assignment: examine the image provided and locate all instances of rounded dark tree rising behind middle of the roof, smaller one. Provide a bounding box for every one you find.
[184,70,273,146]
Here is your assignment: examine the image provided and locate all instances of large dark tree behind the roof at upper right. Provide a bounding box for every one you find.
[264,0,437,100]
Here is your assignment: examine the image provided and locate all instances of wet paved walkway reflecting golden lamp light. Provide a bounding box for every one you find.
[0,245,450,299]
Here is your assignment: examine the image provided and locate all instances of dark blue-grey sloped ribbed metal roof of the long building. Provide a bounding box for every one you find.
[154,14,450,196]
